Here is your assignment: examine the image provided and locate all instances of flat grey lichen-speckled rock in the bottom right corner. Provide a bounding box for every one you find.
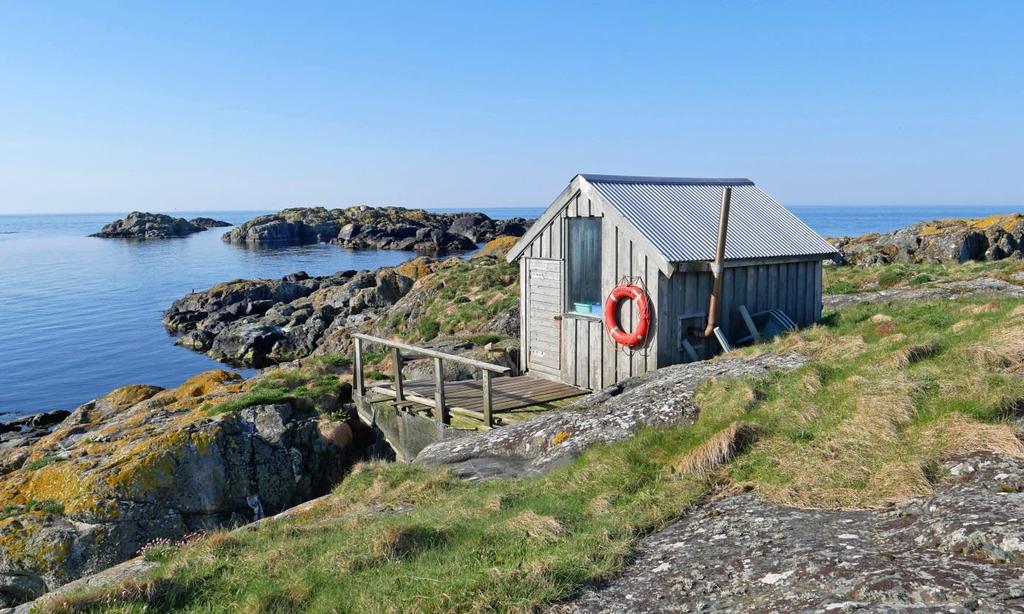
[554,448,1024,613]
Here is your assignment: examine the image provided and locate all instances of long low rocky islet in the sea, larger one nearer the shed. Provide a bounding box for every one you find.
[223,207,530,252]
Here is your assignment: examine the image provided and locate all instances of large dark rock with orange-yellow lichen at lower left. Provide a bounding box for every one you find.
[0,371,358,605]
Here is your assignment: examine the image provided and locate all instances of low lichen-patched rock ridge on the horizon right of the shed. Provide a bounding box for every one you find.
[833,213,1024,264]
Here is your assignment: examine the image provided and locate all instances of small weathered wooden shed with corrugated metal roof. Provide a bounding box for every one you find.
[508,175,836,390]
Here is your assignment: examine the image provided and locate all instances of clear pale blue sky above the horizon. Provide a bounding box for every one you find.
[0,1,1024,213]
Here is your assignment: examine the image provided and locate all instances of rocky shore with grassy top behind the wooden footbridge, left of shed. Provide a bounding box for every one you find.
[164,237,519,366]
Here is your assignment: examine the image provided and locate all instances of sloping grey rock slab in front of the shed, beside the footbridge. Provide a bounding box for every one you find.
[416,354,807,479]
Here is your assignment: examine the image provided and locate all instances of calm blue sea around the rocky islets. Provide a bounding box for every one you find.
[0,206,1019,414]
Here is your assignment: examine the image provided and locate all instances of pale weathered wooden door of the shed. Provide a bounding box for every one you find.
[526,258,562,376]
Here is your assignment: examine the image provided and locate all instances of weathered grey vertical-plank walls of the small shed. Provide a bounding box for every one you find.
[520,193,821,390]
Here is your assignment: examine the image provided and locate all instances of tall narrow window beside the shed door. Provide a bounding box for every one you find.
[566,218,601,315]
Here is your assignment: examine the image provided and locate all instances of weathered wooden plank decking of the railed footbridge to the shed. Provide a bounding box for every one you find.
[371,376,587,413]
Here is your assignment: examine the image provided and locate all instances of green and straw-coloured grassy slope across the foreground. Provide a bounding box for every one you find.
[51,264,1024,612]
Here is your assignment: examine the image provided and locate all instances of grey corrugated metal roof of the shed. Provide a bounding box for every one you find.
[582,175,836,262]
